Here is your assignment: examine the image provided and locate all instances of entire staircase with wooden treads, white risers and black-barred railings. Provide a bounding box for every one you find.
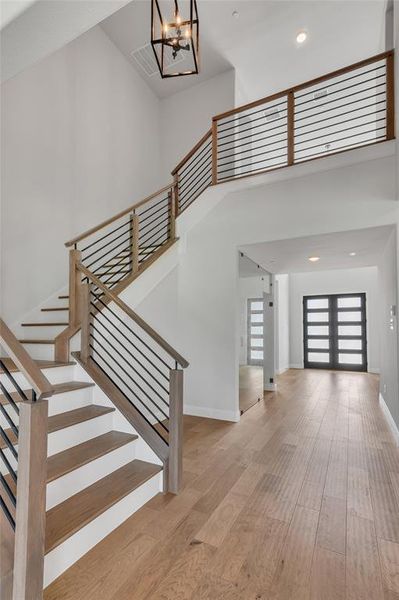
[0,51,394,600]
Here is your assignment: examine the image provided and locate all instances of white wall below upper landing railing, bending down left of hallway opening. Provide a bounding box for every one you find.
[178,156,397,419]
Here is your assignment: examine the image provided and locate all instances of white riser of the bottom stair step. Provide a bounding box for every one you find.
[44,472,162,587]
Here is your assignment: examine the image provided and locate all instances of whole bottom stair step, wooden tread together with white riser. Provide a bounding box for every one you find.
[44,460,162,587]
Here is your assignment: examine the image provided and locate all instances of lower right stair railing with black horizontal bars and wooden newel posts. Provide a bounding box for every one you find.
[78,264,188,488]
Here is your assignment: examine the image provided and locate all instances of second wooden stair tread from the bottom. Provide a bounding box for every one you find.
[47,431,138,482]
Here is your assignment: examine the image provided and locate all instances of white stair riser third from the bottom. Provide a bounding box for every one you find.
[0,413,113,474]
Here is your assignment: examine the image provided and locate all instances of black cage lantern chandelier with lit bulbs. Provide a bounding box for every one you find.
[151,0,199,78]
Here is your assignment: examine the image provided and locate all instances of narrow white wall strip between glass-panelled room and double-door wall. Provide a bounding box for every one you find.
[274,273,290,374]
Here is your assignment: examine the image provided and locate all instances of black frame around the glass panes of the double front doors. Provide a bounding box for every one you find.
[303,292,367,371]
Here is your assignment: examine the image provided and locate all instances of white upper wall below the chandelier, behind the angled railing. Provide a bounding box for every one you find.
[161,69,235,182]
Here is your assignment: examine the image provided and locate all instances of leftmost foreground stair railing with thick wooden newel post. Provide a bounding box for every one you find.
[0,318,54,598]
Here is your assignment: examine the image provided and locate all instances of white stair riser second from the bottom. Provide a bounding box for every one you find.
[46,441,136,510]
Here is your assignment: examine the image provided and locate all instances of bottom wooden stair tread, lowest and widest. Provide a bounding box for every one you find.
[45,460,161,553]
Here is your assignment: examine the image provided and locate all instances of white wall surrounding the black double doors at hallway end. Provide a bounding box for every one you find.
[289,267,380,373]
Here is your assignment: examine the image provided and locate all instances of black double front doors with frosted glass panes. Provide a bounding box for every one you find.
[303,293,367,371]
